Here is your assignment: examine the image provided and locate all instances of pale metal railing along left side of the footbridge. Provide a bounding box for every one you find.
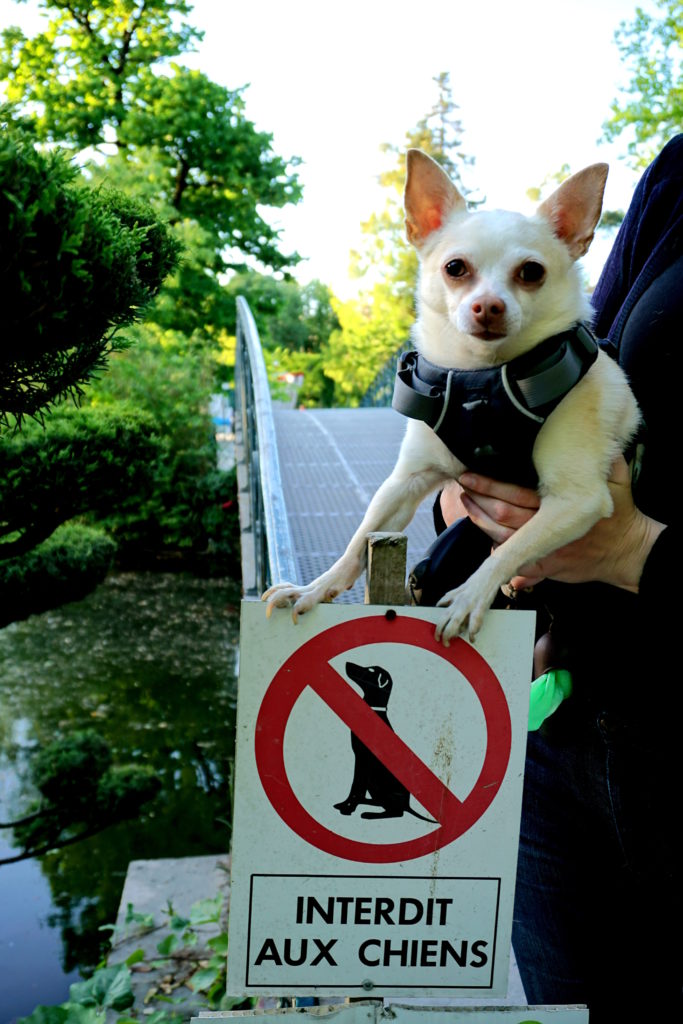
[234,296,298,597]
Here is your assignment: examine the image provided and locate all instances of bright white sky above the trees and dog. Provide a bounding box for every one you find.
[0,0,656,298]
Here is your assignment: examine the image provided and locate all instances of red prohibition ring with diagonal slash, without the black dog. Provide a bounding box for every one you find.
[254,614,512,864]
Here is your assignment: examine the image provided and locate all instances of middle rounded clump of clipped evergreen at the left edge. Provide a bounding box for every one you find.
[0,404,162,561]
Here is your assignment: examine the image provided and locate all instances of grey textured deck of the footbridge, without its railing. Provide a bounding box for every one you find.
[273,406,434,604]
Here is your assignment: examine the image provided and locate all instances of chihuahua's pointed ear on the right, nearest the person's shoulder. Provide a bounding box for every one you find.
[538,164,609,259]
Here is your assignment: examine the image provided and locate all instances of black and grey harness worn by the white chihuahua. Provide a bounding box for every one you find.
[391,324,598,487]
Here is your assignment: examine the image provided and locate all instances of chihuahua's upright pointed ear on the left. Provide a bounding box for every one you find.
[403,150,467,249]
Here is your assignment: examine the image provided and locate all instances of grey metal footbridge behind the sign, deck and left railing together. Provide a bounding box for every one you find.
[234,296,434,604]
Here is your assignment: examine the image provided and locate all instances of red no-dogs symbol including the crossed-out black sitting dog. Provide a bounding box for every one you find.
[254,615,512,864]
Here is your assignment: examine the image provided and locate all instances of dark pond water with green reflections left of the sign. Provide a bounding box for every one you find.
[0,573,240,1024]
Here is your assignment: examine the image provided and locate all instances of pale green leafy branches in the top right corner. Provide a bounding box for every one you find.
[603,0,683,168]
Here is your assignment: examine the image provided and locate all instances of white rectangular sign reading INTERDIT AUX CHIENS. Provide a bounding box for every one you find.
[228,601,533,996]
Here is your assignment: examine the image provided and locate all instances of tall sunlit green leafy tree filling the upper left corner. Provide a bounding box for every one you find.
[0,0,301,284]
